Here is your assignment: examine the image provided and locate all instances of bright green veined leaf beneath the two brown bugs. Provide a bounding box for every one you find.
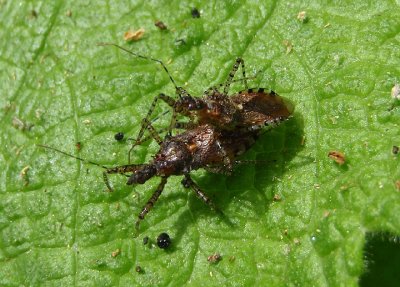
[0,0,400,286]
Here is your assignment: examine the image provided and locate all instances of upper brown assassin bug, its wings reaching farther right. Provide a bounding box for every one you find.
[99,43,293,163]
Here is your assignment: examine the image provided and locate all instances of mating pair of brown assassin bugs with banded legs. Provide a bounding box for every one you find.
[41,43,293,233]
